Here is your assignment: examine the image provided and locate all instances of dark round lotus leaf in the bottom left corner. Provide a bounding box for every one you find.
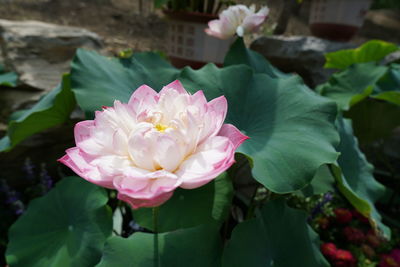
[6,177,112,267]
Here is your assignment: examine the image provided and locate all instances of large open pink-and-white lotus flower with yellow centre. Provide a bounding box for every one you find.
[59,81,248,208]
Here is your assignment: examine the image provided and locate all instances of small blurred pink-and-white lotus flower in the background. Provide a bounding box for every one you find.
[205,5,269,40]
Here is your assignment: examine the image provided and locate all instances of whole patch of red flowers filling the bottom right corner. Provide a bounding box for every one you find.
[315,204,392,267]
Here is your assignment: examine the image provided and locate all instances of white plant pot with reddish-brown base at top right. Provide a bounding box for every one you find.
[310,0,371,41]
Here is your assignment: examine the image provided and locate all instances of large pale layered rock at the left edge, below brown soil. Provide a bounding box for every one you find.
[0,20,102,91]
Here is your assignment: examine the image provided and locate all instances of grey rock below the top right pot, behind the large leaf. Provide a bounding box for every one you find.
[251,36,355,87]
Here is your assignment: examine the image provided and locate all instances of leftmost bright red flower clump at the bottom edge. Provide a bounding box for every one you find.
[321,243,357,267]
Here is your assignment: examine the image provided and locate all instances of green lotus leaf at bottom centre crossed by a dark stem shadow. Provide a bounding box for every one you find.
[96,225,222,267]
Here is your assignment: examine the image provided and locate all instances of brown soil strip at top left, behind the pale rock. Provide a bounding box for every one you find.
[0,0,166,54]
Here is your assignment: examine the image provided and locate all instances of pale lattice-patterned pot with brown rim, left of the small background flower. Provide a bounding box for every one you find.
[164,11,233,69]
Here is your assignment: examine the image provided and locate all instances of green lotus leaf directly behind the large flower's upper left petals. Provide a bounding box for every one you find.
[71,49,179,114]
